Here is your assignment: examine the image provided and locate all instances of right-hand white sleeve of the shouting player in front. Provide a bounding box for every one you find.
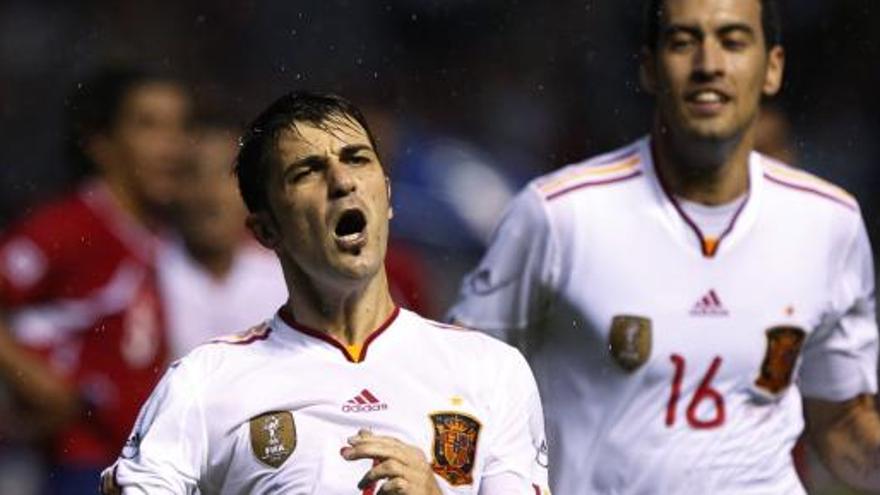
[480,350,550,495]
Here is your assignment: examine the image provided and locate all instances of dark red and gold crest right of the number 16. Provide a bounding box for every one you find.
[755,326,806,395]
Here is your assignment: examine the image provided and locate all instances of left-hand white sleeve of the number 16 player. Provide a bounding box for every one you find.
[447,187,558,341]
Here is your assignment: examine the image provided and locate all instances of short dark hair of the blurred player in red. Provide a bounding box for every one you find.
[65,65,182,173]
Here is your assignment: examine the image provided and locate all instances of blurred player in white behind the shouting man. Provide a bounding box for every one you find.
[156,119,287,360]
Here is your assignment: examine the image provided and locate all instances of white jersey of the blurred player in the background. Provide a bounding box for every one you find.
[157,239,287,359]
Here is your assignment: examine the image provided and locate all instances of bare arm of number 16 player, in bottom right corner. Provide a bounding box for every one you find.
[804,395,880,493]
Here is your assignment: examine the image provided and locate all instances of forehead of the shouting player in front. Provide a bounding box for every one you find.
[278,116,372,163]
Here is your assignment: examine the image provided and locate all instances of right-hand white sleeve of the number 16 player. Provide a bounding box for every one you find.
[800,217,878,401]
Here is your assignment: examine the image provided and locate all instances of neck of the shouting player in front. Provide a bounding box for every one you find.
[285,269,394,345]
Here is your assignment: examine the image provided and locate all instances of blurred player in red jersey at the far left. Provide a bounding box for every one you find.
[0,68,190,493]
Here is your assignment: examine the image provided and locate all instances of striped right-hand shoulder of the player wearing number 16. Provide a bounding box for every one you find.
[758,154,859,213]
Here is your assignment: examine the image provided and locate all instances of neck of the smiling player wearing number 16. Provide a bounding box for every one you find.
[652,119,754,206]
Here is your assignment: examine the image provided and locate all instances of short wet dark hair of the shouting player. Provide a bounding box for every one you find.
[235,91,387,212]
